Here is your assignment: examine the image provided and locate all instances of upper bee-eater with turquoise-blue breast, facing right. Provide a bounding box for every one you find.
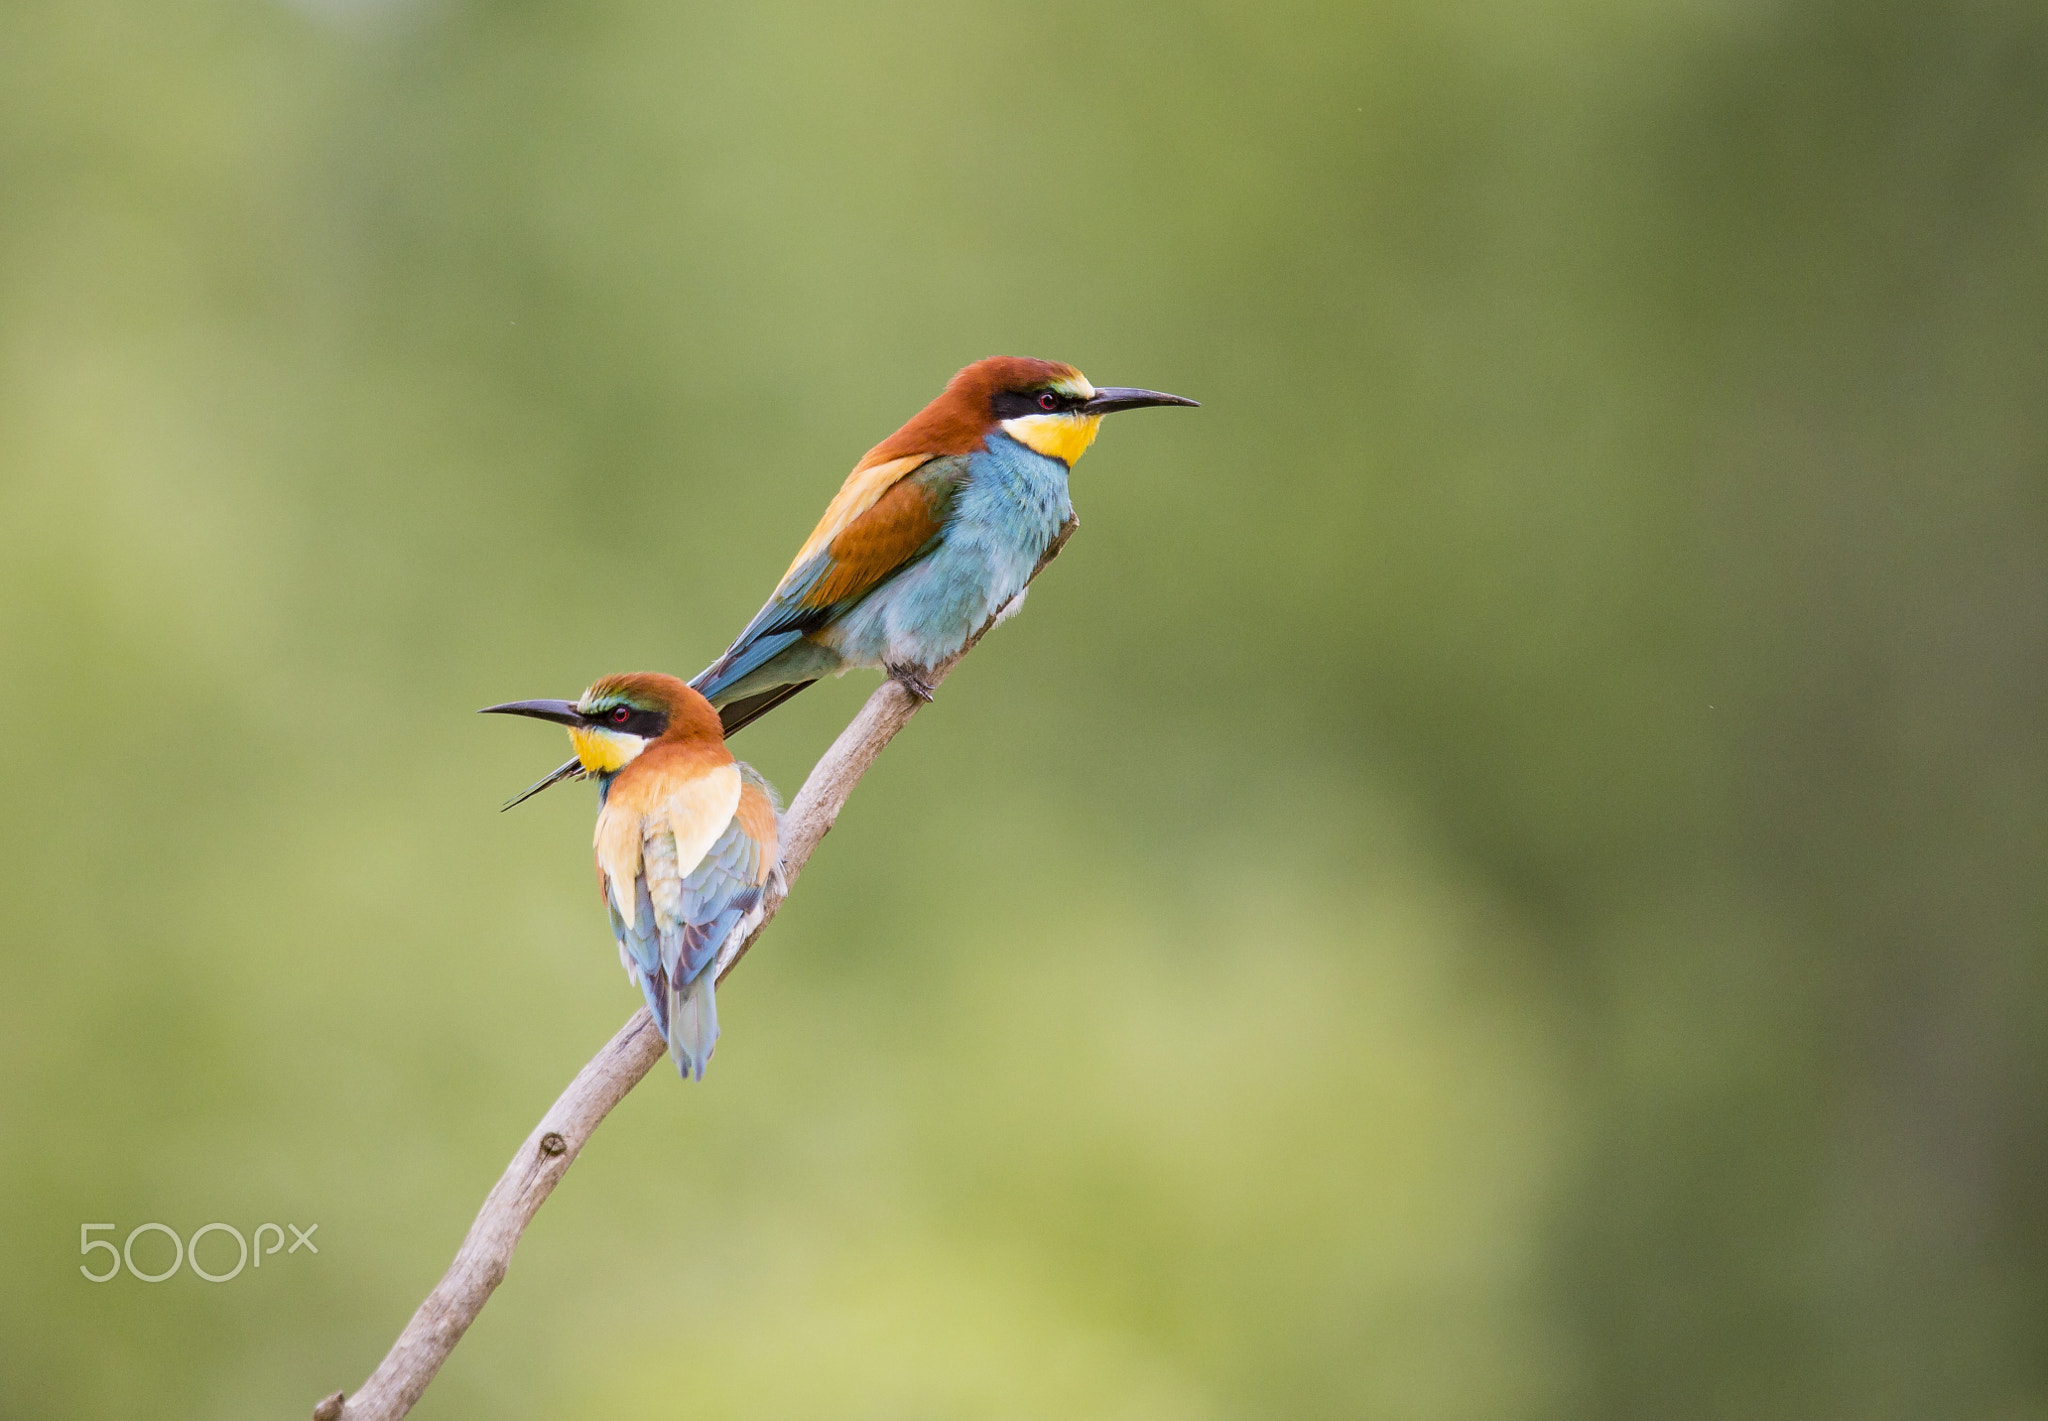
[690,356,1196,735]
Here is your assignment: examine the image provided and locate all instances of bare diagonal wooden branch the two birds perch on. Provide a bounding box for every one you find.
[313,518,1079,1421]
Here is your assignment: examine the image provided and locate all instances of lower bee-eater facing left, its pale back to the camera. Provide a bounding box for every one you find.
[483,672,782,1081]
